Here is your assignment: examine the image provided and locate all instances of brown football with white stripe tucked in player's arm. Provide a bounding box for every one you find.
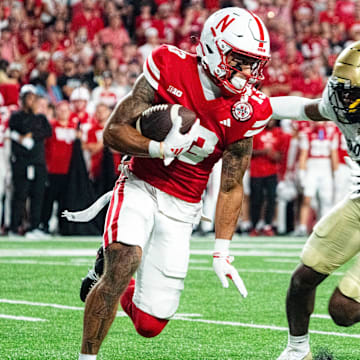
[136,104,197,141]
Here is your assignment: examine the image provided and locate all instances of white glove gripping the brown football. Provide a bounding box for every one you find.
[149,116,200,166]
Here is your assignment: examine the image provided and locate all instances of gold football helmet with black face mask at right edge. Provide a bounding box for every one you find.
[329,41,360,124]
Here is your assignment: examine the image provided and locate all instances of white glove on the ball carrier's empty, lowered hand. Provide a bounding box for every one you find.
[213,239,248,298]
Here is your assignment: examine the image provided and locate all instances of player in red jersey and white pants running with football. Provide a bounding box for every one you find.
[79,7,272,360]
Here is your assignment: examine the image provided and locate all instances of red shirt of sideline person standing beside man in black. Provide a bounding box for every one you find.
[45,120,77,174]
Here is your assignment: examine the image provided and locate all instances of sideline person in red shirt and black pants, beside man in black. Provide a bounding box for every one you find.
[42,101,77,234]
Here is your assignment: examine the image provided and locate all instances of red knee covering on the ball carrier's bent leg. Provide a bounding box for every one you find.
[120,279,169,338]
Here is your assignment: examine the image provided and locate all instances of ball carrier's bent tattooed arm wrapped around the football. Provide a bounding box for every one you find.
[103,75,155,157]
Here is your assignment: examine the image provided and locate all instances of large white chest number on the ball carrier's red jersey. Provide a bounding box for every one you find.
[178,125,219,165]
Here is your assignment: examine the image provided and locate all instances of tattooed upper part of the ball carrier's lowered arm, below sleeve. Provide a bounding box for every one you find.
[221,138,252,192]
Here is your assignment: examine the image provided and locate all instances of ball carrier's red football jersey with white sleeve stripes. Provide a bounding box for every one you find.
[130,45,272,203]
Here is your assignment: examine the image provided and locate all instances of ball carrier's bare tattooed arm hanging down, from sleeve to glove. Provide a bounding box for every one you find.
[215,138,252,240]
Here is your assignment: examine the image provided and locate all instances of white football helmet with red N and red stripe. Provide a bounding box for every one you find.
[196,7,270,94]
